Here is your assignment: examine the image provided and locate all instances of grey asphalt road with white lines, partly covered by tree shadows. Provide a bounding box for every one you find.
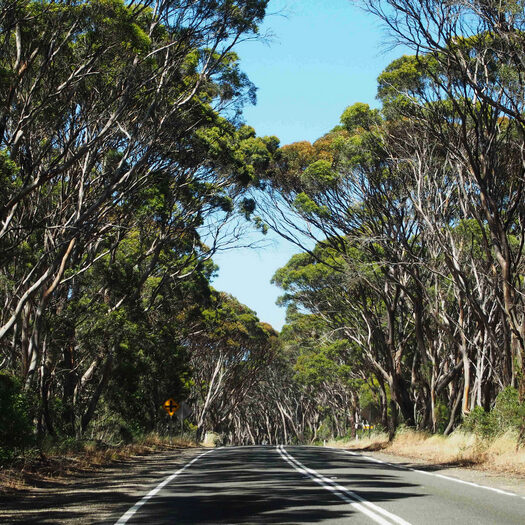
[112,447,525,525]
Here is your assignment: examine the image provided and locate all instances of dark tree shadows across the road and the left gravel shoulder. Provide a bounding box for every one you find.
[0,447,422,525]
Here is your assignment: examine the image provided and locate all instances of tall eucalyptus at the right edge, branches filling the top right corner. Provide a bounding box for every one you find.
[365,0,525,399]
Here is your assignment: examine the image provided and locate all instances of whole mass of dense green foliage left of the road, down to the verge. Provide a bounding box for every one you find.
[0,0,279,450]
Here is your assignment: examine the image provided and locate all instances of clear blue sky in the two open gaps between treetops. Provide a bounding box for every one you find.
[209,0,402,330]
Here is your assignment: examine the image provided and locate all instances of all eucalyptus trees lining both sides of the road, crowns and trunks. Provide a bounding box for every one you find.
[0,0,525,452]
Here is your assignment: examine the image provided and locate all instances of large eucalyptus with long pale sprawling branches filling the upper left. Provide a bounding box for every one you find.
[0,0,276,440]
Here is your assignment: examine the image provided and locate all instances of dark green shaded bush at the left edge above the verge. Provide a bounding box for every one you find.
[0,372,35,460]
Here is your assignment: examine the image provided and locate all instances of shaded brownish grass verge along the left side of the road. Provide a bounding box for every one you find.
[0,433,197,494]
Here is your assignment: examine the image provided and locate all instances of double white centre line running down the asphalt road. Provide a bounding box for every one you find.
[278,445,410,525]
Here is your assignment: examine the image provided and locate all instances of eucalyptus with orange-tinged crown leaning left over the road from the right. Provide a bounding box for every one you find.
[255,104,438,424]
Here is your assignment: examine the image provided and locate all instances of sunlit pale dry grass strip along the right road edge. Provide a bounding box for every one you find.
[326,428,525,476]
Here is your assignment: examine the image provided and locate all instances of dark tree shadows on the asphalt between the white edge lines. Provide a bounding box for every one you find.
[124,449,422,525]
